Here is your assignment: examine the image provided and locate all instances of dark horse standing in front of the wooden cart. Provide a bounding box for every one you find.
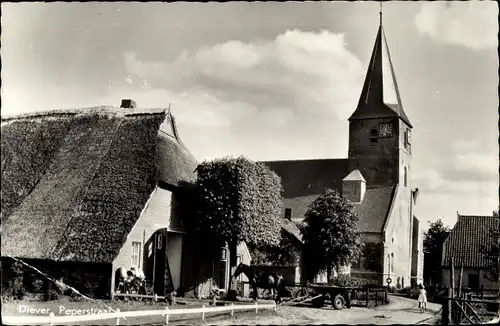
[233,263,285,302]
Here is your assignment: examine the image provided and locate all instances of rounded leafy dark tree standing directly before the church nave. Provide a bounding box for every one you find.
[301,189,363,281]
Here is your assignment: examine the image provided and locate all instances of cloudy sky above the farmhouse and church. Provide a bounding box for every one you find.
[1,1,499,227]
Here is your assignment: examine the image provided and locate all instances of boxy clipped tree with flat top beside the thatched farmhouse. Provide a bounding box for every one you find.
[185,157,283,296]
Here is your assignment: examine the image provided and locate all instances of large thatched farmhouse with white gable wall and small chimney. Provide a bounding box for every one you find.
[1,100,197,296]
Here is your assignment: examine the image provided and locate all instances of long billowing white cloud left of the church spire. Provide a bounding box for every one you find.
[124,30,364,119]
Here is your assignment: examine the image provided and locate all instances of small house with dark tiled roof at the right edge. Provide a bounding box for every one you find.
[441,214,500,289]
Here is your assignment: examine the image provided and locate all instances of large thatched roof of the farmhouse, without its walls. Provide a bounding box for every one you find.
[1,107,196,262]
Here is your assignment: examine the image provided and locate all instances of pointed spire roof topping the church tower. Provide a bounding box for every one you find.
[349,24,412,127]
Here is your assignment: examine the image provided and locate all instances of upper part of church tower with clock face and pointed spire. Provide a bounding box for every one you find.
[348,13,412,189]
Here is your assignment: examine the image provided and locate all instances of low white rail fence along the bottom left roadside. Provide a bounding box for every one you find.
[2,303,276,325]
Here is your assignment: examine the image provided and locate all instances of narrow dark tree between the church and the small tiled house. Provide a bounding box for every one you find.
[424,219,451,283]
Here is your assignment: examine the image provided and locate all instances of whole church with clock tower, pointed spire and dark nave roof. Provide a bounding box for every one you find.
[264,16,423,286]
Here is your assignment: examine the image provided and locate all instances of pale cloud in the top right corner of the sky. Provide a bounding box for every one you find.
[415,1,498,50]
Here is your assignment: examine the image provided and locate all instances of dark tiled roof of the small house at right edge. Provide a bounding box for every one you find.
[442,215,499,268]
